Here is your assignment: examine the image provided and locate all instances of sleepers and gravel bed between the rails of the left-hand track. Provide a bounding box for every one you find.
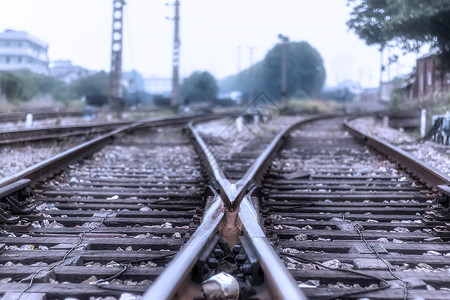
[0,124,205,299]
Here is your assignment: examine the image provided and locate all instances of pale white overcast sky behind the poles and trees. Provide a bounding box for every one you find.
[0,0,417,87]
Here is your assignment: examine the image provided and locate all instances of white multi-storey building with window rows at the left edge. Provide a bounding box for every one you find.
[0,29,48,74]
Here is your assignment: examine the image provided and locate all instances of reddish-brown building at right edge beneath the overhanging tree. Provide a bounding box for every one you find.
[413,53,450,98]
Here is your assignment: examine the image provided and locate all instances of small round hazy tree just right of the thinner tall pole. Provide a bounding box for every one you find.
[181,71,219,103]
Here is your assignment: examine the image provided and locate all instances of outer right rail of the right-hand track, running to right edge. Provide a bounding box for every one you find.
[344,118,450,191]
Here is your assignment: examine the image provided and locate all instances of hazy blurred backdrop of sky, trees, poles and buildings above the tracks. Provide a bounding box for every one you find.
[0,0,450,115]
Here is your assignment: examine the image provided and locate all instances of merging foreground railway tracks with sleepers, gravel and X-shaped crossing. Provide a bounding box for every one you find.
[0,113,450,299]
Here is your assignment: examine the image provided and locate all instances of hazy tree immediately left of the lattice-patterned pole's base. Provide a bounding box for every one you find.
[72,71,109,106]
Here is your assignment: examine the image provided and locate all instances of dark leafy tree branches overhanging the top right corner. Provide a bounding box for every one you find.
[347,0,450,66]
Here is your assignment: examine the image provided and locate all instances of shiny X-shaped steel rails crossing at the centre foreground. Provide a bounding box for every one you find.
[143,115,333,300]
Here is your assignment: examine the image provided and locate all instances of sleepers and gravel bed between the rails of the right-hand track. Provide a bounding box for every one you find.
[262,120,450,299]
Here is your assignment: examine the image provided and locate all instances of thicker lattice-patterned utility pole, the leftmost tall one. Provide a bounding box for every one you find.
[108,0,125,118]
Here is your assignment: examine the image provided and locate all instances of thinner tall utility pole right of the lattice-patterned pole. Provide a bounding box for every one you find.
[170,0,180,112]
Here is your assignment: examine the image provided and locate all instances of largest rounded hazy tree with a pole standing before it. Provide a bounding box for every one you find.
[262,42,326,99]
